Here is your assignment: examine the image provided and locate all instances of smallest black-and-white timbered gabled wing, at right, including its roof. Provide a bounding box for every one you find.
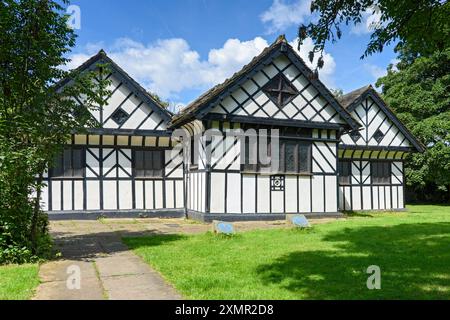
[339,86,425,211]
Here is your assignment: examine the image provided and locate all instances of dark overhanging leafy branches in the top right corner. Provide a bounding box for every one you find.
[298,0,450,64]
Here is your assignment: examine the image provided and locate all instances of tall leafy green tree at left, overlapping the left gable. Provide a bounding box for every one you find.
[0,0,107,264]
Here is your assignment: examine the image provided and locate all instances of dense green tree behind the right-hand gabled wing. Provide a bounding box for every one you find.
[377,48,450,201]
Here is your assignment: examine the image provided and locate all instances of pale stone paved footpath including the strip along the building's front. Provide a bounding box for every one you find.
[34,219,338,300]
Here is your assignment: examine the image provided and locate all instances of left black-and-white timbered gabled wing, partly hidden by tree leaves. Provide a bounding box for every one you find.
[43,51,184,216]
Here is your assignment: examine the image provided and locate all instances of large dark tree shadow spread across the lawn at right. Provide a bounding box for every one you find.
[257,223,450,299]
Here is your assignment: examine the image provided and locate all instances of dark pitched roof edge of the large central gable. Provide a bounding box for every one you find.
[172,35,360,129]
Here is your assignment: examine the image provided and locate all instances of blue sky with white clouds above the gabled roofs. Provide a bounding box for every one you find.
[69,0,395,109]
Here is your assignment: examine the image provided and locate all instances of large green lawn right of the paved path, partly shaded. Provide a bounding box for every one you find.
[124,206,450,299]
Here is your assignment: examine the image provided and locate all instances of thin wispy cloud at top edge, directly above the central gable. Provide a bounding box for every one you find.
[260,0,311,34]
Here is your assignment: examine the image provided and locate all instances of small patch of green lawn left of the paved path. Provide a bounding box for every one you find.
[0,264,39,300]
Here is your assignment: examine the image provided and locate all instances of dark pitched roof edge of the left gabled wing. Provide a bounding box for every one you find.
[56,49,172,122]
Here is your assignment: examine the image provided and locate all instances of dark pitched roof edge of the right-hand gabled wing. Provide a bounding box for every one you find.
[338,85,426,152]
